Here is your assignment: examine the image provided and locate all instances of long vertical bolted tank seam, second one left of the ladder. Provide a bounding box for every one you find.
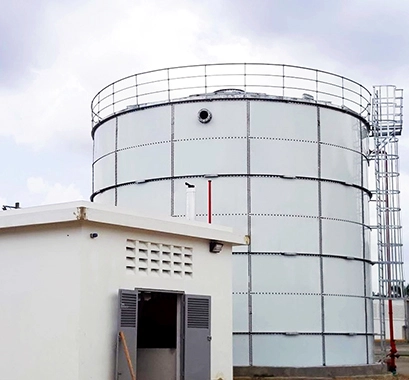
[317,106,326,366]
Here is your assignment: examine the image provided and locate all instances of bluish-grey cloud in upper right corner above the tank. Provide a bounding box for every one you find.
[212,0,409,74]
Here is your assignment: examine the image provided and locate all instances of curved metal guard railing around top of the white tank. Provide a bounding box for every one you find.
[91,63,371,127]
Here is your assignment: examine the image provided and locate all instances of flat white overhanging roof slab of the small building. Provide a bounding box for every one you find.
[0,201,247,245]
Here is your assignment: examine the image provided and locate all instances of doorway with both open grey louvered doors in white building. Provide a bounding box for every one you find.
[115,289,211,380]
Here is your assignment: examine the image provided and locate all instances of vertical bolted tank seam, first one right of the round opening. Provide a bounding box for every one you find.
[246,100,253,365]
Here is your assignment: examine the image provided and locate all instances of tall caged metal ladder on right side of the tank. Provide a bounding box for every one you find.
[369,85,404,354]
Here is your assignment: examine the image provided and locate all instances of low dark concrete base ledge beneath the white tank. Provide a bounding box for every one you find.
[233,364,387,380]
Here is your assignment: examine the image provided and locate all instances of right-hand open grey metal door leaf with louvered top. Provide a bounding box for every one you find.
[183,295,211,380]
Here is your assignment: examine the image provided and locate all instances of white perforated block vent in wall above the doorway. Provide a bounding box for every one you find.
[125,239,193,278]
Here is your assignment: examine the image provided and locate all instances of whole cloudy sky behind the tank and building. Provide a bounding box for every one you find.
[0,0,409,278]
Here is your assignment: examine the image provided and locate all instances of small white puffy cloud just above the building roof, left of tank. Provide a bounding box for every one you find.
[27,177,83,205]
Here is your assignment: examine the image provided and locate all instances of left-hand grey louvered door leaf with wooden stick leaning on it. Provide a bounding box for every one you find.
[115,289,138,380]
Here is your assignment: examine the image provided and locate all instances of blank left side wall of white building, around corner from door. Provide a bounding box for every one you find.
[0,227,83,380]
